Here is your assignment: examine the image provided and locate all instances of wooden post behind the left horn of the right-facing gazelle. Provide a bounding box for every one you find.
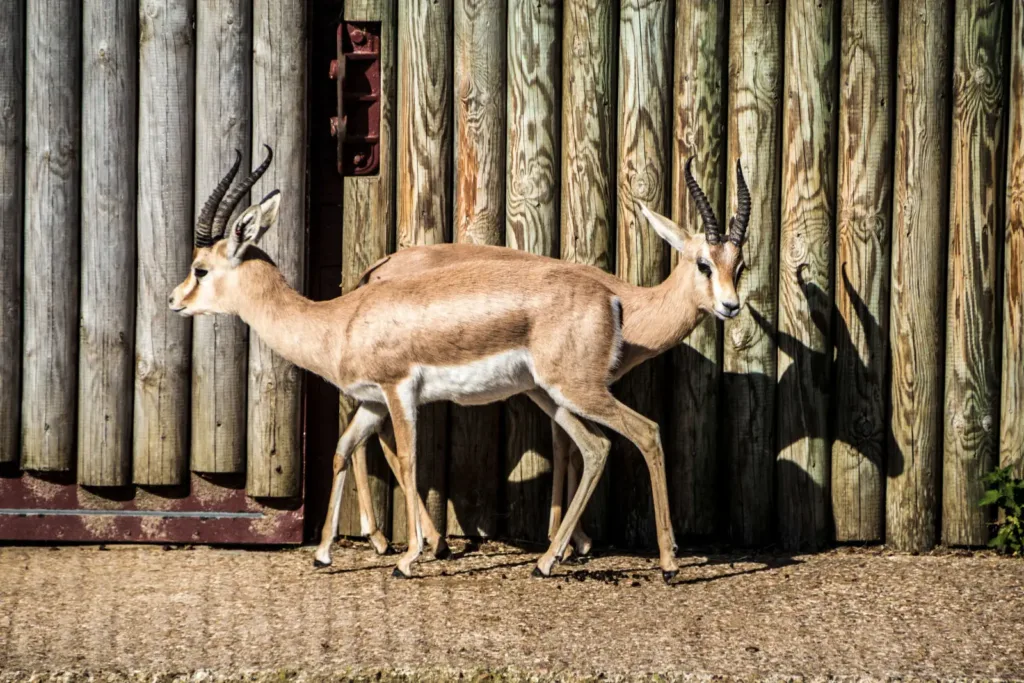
[666,0,729,536]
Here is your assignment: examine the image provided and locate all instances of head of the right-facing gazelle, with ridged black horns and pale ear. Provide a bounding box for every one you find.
[641,157,751,321]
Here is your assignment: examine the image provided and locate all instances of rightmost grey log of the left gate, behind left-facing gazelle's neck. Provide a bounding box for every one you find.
[246,0,307,498]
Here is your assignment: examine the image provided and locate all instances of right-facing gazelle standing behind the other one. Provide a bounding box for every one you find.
[316,160,751,564]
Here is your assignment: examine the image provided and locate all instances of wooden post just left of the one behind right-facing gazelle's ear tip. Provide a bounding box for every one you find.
[560,0,618,541]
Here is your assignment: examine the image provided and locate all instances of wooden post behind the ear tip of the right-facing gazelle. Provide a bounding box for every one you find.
[611,0,673,547]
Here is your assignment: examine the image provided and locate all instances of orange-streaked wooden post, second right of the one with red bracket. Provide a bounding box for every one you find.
[447,0,506,537]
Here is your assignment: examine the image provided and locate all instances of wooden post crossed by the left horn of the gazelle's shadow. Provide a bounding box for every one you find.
[776,0,839,549]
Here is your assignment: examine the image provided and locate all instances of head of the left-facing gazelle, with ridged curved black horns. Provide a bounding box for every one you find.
[168,145,281,316]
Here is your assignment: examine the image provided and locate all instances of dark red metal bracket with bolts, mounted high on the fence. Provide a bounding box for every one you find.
[331,22,381,175]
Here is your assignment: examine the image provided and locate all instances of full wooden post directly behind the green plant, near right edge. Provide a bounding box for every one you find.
[942,0,1010,546]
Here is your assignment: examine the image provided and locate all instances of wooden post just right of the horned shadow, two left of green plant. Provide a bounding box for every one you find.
[886,0,952,552]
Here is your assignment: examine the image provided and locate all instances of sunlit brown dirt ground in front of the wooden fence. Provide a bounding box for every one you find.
[0,544,1024,683]
